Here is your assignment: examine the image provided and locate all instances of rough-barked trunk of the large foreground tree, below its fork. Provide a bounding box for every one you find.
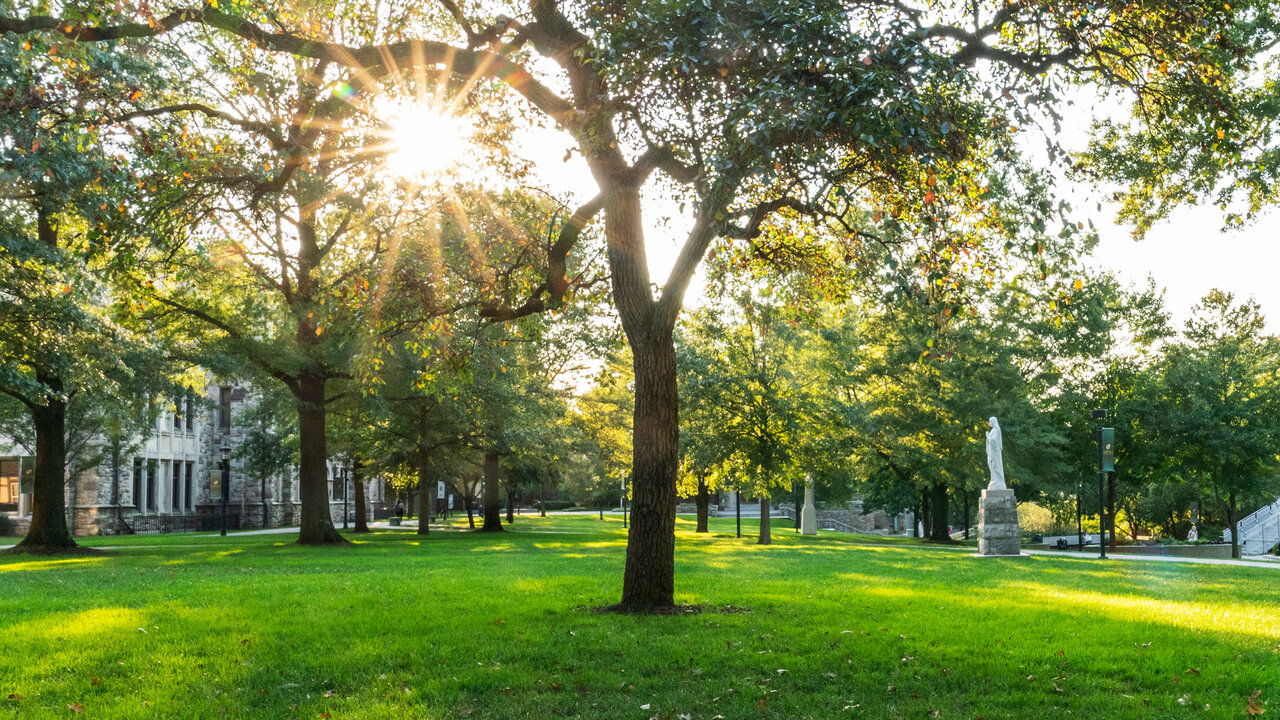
[616,330,680,610]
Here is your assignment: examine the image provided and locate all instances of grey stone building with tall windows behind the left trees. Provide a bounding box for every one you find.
[0,380,385,536]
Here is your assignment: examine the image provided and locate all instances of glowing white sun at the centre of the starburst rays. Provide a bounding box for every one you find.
[387,105,472,177]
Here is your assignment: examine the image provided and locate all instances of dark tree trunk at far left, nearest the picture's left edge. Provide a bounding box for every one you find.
[12,373,79,553]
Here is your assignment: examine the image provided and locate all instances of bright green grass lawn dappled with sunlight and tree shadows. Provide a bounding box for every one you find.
[0,516,1280,720]
